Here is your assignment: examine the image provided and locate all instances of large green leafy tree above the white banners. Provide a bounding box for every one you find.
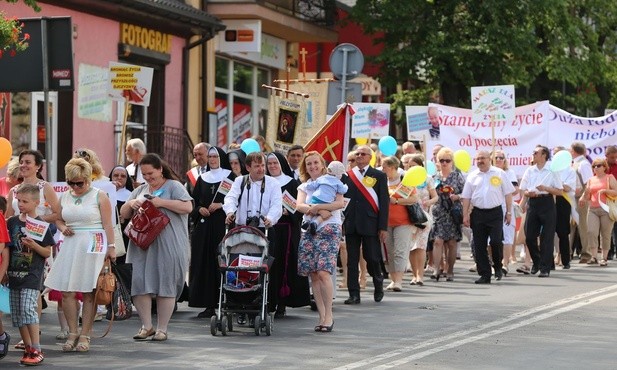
[352,0,617,113]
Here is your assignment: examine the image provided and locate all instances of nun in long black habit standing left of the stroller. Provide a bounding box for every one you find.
[189,147,236,318]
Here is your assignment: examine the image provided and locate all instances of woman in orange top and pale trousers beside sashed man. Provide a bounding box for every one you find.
[381,156,422,292]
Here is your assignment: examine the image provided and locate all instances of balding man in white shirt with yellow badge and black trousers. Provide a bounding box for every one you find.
[461,150,514,284]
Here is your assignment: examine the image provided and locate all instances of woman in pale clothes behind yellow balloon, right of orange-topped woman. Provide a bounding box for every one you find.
[403,154,438,285]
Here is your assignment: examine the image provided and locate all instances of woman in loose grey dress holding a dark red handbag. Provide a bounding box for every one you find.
[120,153,193,341]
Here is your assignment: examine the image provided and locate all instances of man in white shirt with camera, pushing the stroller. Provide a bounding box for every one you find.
[223,152,283,232]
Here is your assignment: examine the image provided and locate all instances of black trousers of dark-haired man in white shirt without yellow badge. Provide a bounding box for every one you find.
[525,196,556,273]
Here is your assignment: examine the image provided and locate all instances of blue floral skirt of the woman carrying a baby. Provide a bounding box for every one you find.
[298,224,342,276]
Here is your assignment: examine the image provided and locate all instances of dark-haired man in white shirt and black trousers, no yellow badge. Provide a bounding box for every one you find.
[521,145,563,278]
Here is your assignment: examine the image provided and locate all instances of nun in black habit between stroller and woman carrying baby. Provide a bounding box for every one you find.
[266,152,310,317]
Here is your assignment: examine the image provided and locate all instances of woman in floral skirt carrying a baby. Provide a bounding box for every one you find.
[296,151,344,332]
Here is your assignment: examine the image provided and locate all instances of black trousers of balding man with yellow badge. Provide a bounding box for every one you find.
[470,206,503,279]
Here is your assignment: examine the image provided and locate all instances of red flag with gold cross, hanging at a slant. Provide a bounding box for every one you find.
[304,104,353,162]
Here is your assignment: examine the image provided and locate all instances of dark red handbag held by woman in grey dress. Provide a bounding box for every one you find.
[124,199,169,250]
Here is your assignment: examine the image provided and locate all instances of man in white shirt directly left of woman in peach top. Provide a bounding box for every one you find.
[570,142,593,263]
